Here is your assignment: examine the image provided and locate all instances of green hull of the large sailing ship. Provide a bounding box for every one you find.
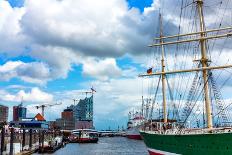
[140,132,232,155]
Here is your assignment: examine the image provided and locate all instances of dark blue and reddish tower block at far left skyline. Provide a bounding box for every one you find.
[13,104,27,121]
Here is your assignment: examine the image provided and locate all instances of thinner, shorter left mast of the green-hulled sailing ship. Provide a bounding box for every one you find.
[159,13,167,123]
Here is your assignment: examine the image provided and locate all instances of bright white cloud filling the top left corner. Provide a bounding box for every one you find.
[0,0,29,57]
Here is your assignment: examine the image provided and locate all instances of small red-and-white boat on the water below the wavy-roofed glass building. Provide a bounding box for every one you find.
[69,129,98,143]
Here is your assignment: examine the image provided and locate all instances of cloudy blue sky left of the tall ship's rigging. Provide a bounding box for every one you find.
[0,0,232,129]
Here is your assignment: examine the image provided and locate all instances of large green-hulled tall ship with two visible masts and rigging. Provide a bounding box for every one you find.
[139,0,232,155]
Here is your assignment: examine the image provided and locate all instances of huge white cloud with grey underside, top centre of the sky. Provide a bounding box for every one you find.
[20,0,151,57]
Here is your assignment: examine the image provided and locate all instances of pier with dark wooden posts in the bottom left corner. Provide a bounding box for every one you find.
[1,127,65,155]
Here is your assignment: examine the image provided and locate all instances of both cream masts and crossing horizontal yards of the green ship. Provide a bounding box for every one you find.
[139,0,232,129]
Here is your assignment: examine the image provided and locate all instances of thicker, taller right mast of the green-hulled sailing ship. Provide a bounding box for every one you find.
[196,0,213,129]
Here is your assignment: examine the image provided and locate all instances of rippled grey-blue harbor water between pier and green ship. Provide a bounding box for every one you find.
[34,137,148,155]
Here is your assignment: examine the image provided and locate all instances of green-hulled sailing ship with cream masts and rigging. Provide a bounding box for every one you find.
[139,0,232,155]
